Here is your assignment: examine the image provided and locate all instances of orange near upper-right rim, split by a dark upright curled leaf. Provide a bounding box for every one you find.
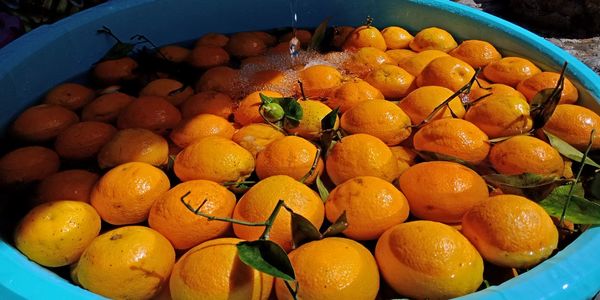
[517,72,579,104]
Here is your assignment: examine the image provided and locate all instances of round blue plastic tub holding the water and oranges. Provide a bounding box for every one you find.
[0,0,600,299]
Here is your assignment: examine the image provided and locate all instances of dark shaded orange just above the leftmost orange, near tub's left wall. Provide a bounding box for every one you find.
[11,104,79,142]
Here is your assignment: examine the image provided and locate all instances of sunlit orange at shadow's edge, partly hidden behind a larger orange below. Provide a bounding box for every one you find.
[169,114,235,148]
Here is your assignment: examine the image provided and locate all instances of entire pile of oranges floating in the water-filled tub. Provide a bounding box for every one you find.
[0,19,600,299]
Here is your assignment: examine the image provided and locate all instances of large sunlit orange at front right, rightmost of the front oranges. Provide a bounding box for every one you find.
[462,195,558,268]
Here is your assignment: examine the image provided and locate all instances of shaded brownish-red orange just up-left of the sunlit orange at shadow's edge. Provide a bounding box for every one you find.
[117,96,181,133]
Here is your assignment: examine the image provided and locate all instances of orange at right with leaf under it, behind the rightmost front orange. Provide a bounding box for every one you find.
[489,135,564,176]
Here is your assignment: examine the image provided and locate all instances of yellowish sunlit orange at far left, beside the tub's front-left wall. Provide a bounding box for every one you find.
[15,200,100,267]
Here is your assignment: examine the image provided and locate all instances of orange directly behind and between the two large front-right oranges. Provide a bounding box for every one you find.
[399,161,489,223]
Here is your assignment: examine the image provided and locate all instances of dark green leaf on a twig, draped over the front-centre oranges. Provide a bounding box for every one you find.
[237,240,296,280]
